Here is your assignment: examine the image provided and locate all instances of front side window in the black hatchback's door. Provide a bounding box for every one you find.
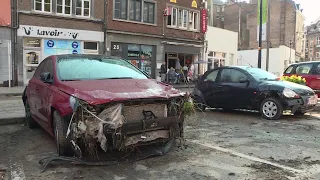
[221,69,247,83]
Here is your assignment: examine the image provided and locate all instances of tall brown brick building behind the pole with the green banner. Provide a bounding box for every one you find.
[224,0,304,61]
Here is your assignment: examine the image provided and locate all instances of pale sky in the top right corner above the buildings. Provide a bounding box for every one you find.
[222,0,320,25]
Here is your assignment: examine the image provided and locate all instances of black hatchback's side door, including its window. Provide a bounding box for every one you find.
[218,68,255,109]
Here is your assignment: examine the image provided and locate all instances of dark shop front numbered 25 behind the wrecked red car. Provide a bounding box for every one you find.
[111,42,156,77]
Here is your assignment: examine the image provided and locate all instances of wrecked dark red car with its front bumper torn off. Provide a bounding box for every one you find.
[23,55,185,156]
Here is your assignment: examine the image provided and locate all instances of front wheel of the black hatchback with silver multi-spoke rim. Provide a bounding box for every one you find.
[260,98,283,120]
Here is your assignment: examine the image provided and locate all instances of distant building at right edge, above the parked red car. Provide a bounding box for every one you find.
[305,18,320,60]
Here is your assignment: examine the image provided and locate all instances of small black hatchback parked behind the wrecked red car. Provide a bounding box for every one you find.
[192,66,318,120]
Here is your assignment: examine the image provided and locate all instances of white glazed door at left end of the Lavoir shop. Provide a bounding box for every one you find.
[23,50,41,84]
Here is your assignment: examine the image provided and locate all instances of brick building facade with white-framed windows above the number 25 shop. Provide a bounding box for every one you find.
[107,0,204,78]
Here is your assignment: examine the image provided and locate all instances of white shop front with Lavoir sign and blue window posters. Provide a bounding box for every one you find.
[18,25,103,85]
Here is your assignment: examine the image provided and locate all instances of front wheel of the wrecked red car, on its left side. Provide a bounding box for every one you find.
[53,111,72,156]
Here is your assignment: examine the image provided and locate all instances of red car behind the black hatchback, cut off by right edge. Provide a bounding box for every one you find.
[283,61,320,97]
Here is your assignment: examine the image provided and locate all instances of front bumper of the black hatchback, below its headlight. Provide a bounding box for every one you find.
[284,96,316,113]
